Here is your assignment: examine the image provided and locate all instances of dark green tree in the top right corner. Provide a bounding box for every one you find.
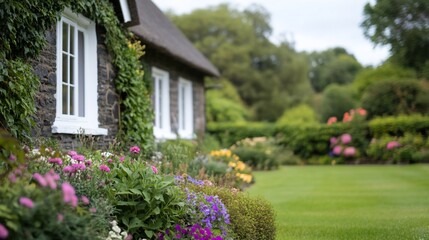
[361,0,429,73]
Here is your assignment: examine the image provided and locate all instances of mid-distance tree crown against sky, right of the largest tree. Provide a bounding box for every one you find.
[308,47,362,92]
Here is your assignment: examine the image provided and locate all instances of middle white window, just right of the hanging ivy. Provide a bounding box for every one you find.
[152,68,176,139]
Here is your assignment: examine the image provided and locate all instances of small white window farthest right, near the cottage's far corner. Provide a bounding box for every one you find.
[177,79,194,138]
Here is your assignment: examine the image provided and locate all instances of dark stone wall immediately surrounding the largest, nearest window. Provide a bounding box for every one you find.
[32,27,119,149]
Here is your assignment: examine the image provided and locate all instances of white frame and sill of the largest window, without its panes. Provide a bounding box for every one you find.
[52,9,107,135]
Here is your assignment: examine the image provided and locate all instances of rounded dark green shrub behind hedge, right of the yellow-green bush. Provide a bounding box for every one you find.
[320,84,356,122]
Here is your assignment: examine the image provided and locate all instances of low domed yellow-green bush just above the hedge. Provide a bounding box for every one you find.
[276,104,319,125]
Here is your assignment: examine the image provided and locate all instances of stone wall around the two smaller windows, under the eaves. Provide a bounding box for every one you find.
[143,45,206,136]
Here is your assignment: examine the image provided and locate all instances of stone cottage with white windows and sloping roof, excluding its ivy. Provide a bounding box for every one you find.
[33,0,219,147]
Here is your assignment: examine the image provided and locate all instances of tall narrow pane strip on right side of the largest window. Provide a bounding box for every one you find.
[77,31,85,117]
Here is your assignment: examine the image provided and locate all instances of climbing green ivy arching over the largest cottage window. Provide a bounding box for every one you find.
[0,0,154,151]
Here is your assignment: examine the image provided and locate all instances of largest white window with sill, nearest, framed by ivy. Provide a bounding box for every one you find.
[52,9,107,135]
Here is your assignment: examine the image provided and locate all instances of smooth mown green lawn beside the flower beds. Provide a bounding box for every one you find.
[248,165,429,240]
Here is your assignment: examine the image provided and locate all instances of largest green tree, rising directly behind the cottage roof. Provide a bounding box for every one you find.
[169,4,312,121]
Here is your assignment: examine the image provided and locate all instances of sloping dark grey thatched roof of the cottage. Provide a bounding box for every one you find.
[128,0,219,76]
